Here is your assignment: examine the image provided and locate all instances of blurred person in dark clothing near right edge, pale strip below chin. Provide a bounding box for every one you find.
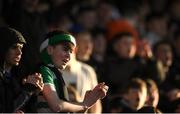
[141,40,173,88]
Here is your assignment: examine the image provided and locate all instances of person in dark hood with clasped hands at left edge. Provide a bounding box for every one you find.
[0,27,43,113]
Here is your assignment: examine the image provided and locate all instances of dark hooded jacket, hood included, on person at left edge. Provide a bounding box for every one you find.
[0,27,35,113]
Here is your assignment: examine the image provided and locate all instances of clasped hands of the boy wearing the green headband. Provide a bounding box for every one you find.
[83,82,109,108]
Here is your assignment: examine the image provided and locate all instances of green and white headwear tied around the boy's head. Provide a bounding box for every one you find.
[40,33,76,64]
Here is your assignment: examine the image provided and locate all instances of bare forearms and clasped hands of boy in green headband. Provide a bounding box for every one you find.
[43,83,107,112]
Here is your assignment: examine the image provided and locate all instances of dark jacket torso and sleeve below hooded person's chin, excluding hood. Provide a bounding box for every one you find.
[0,66,36,113]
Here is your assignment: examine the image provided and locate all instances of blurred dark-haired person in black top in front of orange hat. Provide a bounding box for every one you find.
[104,32,140,94]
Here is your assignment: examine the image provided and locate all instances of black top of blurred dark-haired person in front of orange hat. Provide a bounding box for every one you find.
[104,57,140,94]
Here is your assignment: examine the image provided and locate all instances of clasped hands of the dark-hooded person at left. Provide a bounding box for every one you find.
[24,73,44,91]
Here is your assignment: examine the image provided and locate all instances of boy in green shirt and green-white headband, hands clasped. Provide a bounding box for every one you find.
[38,31,108,112]
